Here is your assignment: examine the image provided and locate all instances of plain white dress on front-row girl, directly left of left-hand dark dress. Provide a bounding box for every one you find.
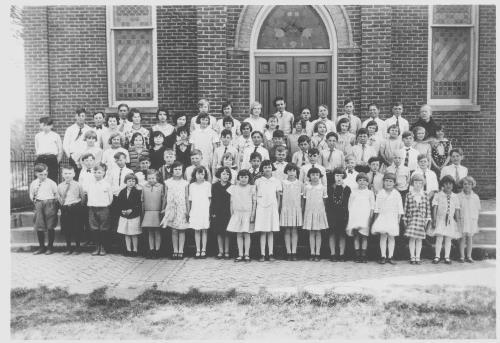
[188,181,212,230]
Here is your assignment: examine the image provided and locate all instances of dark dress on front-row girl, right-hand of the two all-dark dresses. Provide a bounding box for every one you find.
[326,184,351,235]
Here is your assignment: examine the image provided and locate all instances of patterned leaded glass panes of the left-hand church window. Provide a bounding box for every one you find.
[110,6,156,105]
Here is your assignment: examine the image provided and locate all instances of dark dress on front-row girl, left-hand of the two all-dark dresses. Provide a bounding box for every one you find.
[210,182,231,234]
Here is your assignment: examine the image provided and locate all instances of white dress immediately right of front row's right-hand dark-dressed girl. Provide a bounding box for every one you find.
[346,188,375,237]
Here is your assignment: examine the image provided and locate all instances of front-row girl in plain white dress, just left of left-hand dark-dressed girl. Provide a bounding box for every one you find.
[189,166,212,258]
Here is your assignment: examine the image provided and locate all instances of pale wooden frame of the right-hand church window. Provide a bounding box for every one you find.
[427,5,480,111]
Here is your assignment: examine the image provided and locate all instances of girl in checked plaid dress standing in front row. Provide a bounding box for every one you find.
[403,174,432,264]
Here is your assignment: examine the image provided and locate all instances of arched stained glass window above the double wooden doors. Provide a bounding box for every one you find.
[257,6,330,49]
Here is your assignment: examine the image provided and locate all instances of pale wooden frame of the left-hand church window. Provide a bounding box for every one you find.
[106,5,158,108]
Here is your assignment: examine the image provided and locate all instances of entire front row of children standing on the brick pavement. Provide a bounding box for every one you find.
[30,160,480,264]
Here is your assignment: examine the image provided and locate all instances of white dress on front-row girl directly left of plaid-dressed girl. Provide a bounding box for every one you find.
[372,189,404,236]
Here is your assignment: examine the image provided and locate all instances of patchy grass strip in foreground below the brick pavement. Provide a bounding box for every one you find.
[11,287,496,340]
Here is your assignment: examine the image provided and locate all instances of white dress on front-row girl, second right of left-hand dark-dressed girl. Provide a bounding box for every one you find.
[255,177,281,232]
